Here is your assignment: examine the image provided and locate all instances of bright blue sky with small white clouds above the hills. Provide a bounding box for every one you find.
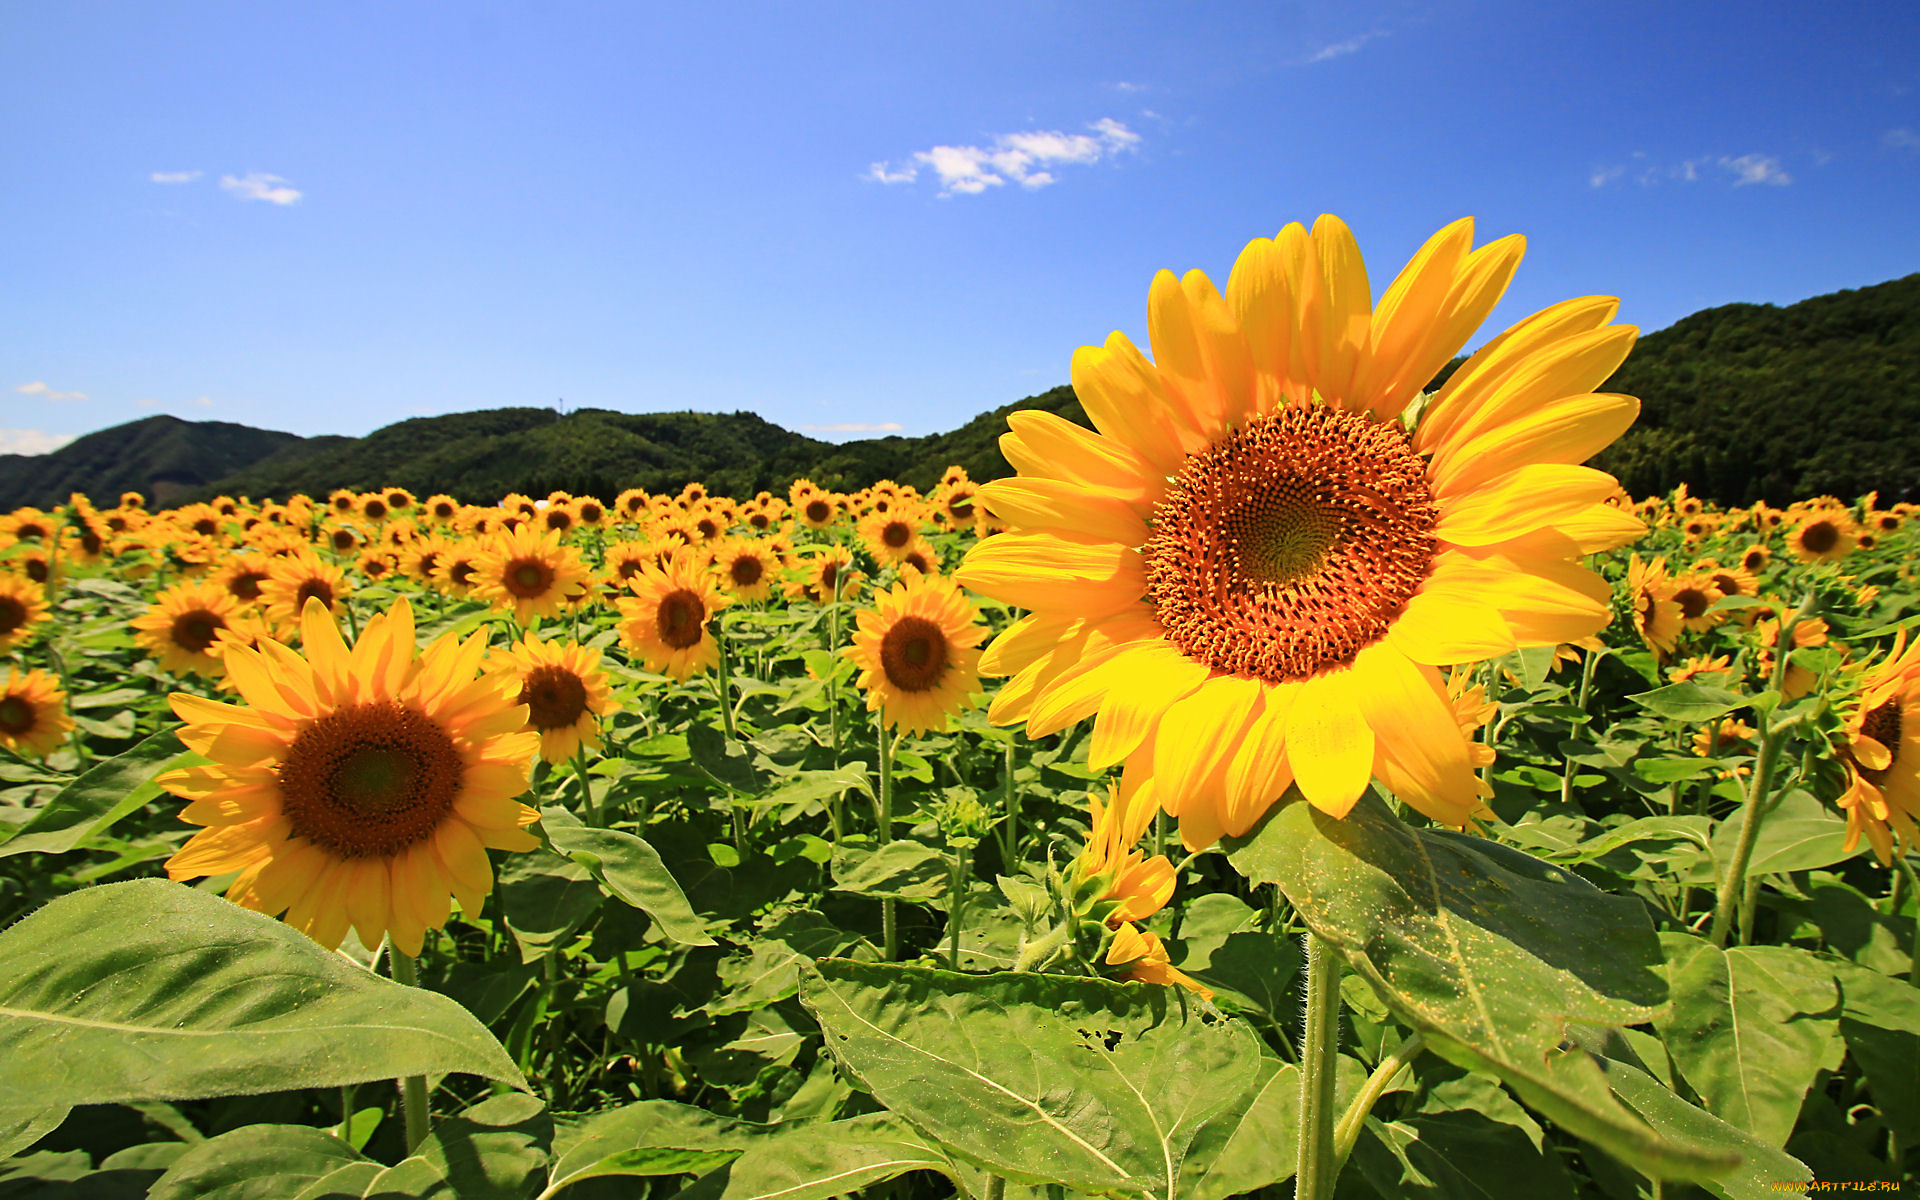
[0,0,1920,451]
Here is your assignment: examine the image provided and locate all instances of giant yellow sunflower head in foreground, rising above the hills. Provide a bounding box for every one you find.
[958,217,1644,849]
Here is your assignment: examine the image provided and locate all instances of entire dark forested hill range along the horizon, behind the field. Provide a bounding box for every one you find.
[0,275,1920,511]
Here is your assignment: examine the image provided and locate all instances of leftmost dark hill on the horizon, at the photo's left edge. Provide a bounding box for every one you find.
[0,417,337,511]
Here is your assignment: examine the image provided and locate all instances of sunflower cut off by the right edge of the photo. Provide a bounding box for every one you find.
[1837,634,1920,866]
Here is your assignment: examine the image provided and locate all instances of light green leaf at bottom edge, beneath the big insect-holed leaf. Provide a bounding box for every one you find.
[674,1112,952,1200]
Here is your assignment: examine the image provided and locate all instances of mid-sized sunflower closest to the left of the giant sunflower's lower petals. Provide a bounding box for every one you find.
[841,574,983,729]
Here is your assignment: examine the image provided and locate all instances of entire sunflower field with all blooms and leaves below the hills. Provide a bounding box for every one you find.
[0,217,1920,1200]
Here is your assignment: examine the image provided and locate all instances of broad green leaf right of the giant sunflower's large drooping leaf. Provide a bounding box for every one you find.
[1655,933,1839,1146]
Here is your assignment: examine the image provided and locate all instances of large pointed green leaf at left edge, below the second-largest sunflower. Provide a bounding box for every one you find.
[0,879,526,1106]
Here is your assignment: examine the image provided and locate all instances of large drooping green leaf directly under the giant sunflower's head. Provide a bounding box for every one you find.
[1223,793,1728,1179]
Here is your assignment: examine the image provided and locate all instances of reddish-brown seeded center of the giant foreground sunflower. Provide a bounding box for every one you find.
[1142,405,1438,684]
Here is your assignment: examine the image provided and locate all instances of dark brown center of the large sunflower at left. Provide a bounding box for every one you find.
[280,701,465,858]
